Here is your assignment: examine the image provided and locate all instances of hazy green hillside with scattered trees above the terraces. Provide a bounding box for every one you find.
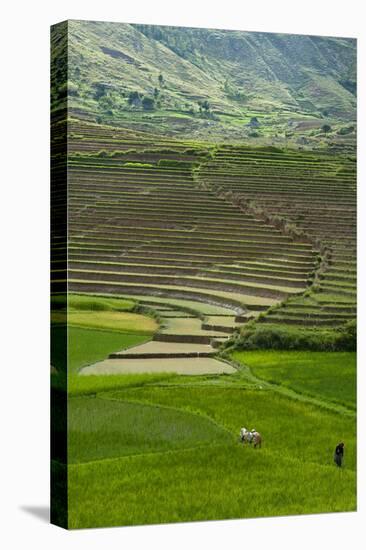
[53,21,356,145]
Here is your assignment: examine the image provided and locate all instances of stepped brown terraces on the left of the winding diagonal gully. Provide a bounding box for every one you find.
[53,121,328,364]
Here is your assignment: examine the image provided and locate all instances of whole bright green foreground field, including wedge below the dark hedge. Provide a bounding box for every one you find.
[59,310,356,528]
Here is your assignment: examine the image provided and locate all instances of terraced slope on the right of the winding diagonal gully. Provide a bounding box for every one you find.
[198,146,356,327]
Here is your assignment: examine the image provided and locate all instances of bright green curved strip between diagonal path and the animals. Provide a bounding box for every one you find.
[114,386,356,469]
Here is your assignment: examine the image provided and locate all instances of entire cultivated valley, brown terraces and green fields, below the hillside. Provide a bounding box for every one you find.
[52,120,356,527]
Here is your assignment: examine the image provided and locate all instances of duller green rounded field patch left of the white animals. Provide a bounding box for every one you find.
[68,393,233,463]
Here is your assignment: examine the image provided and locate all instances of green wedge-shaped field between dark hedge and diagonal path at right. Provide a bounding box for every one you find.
[233,351,356,409]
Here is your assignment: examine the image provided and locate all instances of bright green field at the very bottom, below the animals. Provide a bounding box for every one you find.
[69,440,355,528]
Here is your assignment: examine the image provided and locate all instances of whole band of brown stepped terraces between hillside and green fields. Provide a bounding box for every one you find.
[53,121,356,352]
